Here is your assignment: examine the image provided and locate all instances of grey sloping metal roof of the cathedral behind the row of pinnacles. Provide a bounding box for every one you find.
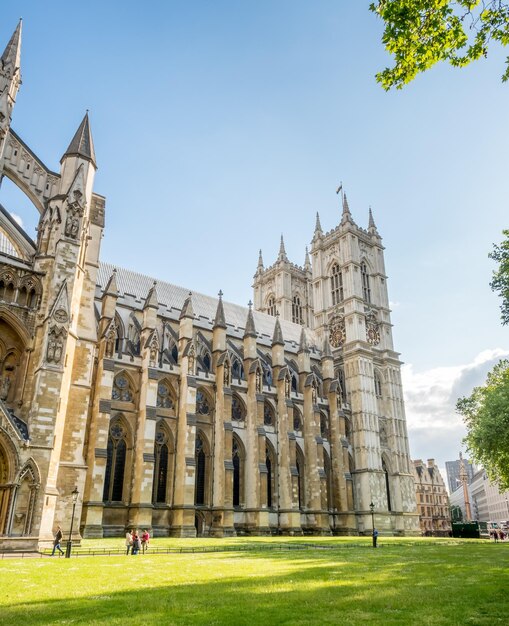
[96,263,319,356]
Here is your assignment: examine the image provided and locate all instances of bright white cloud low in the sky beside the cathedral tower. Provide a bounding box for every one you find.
[401,348,509,468]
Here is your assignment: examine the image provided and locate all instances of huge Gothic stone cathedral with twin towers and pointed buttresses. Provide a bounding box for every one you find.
[0,22,419,550]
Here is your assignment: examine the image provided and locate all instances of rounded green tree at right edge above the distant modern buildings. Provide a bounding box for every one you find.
[456,360,509,491]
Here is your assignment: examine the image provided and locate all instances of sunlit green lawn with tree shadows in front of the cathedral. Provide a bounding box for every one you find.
[0,537,509,626]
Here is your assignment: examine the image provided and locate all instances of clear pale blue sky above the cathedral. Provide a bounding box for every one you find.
[0,0,509,462]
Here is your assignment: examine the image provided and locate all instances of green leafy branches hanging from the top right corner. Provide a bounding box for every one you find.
[370,0,509,90]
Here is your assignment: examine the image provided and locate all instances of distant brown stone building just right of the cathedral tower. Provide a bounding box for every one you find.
[414,459,452,537]
